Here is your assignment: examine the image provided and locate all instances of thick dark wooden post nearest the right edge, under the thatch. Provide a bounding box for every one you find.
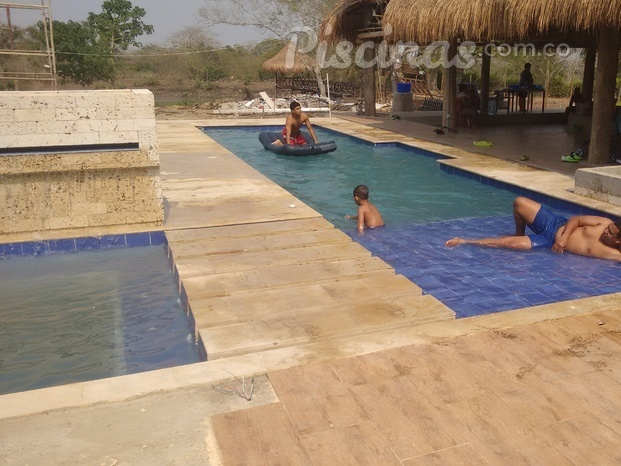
[589,26,619,165]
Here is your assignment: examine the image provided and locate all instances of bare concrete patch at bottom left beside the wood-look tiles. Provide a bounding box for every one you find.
[0,376,277,466]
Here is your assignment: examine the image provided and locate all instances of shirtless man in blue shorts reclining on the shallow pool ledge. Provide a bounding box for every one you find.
[446,196,621,262]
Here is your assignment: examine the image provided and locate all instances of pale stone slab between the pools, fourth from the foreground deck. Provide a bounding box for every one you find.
[175,241,369,279]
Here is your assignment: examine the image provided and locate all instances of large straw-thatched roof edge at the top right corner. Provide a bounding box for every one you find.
[383,0,621,46]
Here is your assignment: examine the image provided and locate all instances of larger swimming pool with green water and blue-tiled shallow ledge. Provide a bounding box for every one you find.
[203,127,621,317]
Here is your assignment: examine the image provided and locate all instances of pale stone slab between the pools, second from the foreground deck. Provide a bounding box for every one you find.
[191,274,422,329]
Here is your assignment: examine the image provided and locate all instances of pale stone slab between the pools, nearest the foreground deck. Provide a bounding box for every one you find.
[199,294,454,359]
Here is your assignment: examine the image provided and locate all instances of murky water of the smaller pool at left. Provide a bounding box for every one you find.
[0,245,200,394]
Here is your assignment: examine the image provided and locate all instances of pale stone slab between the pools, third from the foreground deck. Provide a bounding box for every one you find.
[182,255,394,303]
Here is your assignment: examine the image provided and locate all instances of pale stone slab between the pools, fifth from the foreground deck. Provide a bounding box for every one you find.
[169,229,353,263]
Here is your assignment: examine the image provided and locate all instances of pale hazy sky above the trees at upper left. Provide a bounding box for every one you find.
[0,0,268,45]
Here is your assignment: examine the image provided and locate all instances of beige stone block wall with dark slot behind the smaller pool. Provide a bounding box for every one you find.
[0,90,163,235]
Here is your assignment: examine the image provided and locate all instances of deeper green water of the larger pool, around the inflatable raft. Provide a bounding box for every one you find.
[205,128,515,229]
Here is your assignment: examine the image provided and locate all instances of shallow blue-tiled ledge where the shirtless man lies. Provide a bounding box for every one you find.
[351,216,621,317]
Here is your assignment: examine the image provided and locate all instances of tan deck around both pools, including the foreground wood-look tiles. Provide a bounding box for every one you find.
[0,118,621,465]
